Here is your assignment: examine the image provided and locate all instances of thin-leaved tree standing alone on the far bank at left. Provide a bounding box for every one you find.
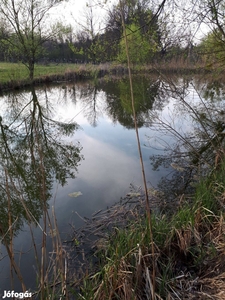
[0,0,63,81]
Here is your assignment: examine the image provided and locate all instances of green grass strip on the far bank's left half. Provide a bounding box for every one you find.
[0,62,118,91]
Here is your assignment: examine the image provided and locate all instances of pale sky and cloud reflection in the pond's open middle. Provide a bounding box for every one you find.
[0,79,165,295]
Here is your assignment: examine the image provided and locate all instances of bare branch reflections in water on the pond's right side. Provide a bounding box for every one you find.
[149,77,225,205]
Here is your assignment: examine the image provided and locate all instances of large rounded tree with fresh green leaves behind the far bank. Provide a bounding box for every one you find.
[106,0,160,63]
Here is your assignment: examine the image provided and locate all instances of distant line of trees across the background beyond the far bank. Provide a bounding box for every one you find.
[0,0,225,80]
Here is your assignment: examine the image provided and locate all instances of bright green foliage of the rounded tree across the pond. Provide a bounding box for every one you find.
[114,1,160,64]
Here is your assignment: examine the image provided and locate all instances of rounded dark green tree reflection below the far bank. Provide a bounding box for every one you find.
[101,77,160,129]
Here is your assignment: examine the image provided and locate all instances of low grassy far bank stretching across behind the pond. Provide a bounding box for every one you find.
[0,61,211,92]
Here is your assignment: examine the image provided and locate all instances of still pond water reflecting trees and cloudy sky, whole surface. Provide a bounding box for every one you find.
[0,77,224,295]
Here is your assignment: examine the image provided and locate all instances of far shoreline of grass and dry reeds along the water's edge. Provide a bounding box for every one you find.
[0,63,216,93]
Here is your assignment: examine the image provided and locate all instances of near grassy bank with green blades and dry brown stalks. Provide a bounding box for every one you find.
[72,158,225,300]
